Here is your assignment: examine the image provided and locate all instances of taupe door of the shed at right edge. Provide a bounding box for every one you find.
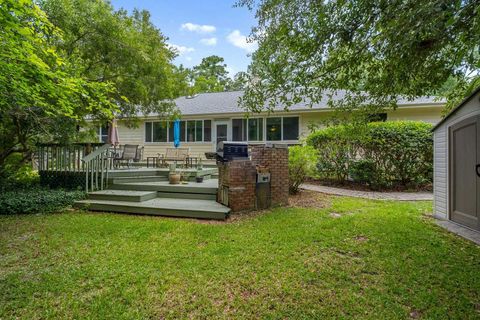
[449,116,480,230]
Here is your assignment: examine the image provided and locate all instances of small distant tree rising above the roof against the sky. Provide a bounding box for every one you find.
[191,56,229,93]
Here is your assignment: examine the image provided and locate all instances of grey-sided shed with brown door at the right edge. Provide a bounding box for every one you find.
[433,87,480,231]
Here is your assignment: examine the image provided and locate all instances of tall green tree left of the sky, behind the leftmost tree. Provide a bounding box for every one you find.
[41,0,182,117]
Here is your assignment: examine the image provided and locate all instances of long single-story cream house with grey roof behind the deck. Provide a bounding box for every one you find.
[104,91,445,158]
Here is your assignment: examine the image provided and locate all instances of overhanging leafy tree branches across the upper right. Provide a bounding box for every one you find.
[238,0,480,115]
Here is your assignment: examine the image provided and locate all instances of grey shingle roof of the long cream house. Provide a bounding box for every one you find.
[166,90,444,115]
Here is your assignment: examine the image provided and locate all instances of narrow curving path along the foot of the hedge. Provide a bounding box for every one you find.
[300,183,433,201]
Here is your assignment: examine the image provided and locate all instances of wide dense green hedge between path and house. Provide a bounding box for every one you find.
[307,121,433,189]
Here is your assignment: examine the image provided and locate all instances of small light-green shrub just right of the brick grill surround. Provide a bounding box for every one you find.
[288,146,317,194]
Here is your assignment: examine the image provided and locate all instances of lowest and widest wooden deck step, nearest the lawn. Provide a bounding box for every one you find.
[75,198,230,220]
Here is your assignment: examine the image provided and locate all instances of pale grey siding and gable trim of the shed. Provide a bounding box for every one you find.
[433,93,480,219]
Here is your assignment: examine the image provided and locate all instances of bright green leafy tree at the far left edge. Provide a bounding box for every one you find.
[0,0,116,178]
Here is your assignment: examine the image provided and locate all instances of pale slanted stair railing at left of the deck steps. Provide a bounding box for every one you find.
[82,144,112,192]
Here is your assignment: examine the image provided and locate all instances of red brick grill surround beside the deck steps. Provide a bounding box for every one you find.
[217,145,288,212]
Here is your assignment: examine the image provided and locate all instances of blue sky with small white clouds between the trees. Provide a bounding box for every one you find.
[111,0,256,75]
